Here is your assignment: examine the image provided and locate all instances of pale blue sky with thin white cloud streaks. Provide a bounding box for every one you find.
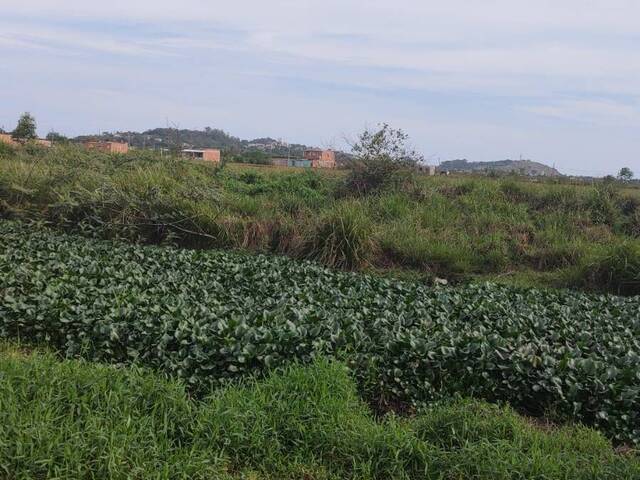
[0,0,640,175]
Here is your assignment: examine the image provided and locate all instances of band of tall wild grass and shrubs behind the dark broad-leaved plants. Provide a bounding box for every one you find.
[0,145,640,294]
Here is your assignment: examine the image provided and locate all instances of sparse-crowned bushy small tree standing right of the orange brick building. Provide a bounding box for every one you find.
[346,123,423,195]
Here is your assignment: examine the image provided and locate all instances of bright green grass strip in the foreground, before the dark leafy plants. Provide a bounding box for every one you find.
[0,344,640,480]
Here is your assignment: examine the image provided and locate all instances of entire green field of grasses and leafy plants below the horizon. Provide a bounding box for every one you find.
[0,144,640,480]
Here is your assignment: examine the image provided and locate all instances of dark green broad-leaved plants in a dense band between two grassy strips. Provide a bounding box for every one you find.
[0,221,640,442]
